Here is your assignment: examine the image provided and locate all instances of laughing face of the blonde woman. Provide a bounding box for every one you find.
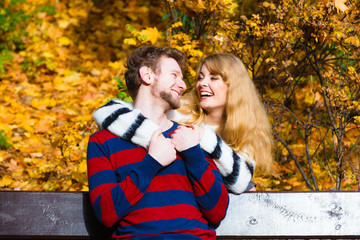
[196,64,229,114]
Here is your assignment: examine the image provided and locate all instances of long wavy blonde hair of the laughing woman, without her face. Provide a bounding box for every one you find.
[179,53,273,172]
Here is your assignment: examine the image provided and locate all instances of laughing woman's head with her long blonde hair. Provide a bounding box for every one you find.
[183,53,273,174]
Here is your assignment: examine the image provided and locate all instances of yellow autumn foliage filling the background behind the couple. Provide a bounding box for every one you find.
[0,0,360,191]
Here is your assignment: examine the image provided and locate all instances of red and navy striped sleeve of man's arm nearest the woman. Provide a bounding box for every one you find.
[180,145,229,225]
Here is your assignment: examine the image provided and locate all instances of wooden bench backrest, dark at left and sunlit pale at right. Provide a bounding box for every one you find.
[0,191,360,239]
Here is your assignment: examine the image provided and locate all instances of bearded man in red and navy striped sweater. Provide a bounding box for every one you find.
[88,46,229,239]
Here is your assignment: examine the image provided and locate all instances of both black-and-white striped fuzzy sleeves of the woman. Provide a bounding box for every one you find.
[94,99,255,194]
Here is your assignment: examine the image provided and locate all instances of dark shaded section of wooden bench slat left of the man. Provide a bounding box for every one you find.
[0,191,110,239]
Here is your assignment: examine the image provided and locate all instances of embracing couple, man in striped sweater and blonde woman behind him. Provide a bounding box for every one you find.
[88,46,271,239]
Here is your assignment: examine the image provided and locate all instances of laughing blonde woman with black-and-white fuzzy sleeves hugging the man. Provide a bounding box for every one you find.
[94,54,272,194]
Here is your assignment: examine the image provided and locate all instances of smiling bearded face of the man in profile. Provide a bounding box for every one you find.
[153,56,186,109]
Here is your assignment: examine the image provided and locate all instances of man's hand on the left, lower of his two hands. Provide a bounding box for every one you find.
[148,130,176,167]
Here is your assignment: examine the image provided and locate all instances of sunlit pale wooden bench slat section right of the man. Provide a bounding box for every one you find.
[217,192,360,238]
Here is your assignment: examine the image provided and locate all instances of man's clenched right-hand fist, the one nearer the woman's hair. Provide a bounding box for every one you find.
[171,125,202,152]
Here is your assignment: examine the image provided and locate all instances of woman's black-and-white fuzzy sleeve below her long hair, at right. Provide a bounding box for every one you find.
[200,127,255,194]
